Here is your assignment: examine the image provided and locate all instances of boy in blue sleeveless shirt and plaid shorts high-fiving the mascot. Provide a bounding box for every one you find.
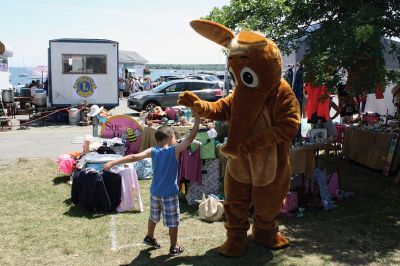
[104,108,200,255]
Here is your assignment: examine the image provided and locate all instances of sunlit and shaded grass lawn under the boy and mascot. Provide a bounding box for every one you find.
[0,159,400,265]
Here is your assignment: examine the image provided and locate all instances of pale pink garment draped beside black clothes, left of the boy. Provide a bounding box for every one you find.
[117,168,143,212]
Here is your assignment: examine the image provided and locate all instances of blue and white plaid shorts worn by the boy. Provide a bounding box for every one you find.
[150,195,179,228]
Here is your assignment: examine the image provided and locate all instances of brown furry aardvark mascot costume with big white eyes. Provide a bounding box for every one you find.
[178,20,300,256]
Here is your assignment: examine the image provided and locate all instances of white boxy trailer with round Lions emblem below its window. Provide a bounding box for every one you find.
[49,39,119,108]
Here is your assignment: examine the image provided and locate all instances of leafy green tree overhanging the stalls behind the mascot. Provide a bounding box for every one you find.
[205,0,400,94]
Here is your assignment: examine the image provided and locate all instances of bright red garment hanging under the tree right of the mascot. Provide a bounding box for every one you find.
[304,83,330,124]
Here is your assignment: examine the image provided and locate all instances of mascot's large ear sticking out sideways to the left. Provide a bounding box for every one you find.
[190,20,235,48]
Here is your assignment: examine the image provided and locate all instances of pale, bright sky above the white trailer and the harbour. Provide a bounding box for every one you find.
[0,0,229,67]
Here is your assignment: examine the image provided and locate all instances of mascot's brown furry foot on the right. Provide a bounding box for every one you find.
[251,229,290,250]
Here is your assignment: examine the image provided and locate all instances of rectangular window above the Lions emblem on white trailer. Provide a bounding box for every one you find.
[62,54,107,74]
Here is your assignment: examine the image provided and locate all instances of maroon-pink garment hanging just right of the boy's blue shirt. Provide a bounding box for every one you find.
[179,148,202,185]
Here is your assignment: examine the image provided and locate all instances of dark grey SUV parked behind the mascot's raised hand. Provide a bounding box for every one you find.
[128,79,223,111]
